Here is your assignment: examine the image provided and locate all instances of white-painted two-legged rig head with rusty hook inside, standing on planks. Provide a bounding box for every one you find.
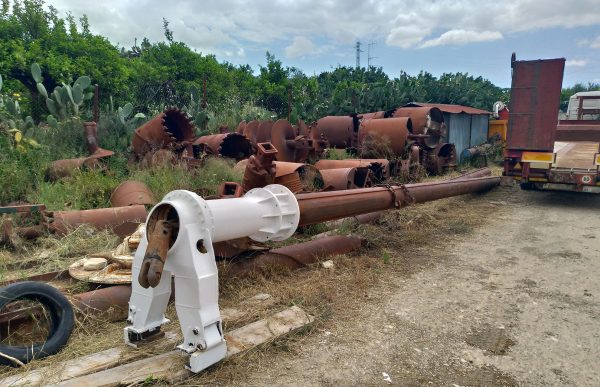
[125,184,300,372]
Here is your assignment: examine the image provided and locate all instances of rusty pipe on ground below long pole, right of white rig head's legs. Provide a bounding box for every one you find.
[225,235,363,277]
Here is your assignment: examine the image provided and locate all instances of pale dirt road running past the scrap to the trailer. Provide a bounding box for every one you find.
[237,187,600,386]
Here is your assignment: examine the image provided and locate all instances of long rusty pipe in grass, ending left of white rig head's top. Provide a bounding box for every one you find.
[49,205,148,237]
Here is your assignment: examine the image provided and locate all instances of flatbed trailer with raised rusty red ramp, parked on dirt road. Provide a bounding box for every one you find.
[504,54,600,193]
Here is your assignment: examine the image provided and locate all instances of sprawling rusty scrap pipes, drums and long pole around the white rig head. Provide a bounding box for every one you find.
[0,107,500,366]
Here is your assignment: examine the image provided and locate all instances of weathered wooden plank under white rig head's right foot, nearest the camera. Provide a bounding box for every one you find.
[58,306,313,387]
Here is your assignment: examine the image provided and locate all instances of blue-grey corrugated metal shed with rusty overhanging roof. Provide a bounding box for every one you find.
[404,102,491,162]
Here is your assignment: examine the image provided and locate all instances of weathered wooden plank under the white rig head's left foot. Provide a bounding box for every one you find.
[0,293,277,386]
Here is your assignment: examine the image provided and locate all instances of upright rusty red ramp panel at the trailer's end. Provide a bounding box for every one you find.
[506,58,565,152]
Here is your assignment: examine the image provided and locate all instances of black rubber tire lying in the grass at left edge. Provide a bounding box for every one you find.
[0,281,75,366]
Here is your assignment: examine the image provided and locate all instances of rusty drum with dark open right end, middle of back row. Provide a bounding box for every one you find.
[311,116,358,148]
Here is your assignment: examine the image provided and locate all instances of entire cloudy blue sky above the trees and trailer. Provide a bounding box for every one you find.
[47,0,600,87]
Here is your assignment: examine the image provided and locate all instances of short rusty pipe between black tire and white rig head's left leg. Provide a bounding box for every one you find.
[71,285,131,321]
